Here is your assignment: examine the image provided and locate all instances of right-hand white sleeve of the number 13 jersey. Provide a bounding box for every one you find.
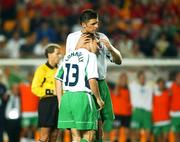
[86,53,99,79]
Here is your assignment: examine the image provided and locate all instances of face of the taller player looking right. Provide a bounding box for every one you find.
[82,18,99,33]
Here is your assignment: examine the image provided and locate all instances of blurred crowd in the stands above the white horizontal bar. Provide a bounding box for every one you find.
[0,0,180,58]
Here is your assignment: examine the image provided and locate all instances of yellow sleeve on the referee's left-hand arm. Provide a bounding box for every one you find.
[31,66,46,97]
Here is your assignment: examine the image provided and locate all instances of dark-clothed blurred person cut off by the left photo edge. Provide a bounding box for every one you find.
[0,69,7,142]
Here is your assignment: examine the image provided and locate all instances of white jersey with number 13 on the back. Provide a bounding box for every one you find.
[55,48,98,92]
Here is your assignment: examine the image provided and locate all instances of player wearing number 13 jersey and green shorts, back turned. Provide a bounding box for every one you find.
[56,36,104,142]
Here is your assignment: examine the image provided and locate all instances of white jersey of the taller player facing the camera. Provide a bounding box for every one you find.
[66,31,112,80]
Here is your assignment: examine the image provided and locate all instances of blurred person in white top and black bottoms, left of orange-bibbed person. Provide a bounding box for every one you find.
[5,84,21,142]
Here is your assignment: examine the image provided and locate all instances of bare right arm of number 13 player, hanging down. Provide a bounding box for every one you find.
[89,78,104,110]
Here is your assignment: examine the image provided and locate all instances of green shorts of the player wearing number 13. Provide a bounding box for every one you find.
[58,91,98,130]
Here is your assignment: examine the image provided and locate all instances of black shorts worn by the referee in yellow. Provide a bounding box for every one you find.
[38,96,58,128]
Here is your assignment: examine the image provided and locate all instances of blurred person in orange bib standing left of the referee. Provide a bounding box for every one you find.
[19,72,39,141]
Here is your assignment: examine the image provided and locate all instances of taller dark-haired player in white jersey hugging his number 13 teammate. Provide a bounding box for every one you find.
[66,9,122,142]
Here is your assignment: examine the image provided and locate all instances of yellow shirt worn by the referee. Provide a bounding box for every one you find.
[31,62,57,98]
